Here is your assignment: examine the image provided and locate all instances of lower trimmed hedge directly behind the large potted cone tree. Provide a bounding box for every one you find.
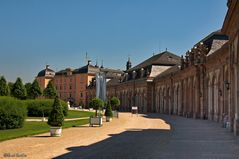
[25,99,68,117]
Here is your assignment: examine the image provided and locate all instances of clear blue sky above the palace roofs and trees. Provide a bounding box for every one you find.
[0,0,227,82]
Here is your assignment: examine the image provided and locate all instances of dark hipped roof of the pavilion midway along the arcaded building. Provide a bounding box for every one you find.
[127,51,180,72]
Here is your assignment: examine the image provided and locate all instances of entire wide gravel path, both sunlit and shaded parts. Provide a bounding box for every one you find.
[0,113,239,159]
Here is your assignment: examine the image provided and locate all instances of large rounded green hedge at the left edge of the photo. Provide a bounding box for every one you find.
[0,97,27,129]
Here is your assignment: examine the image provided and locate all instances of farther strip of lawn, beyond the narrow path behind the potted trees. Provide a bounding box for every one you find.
[27,110,95,119]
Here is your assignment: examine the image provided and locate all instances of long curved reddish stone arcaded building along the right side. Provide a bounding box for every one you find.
[87,0,239,135]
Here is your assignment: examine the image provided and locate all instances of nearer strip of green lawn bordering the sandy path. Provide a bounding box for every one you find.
[0,119,89,141]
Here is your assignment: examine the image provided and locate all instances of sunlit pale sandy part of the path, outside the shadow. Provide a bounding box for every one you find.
[0,113,170,159]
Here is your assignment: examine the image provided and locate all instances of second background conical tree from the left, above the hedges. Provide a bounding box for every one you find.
[12,77,27,99]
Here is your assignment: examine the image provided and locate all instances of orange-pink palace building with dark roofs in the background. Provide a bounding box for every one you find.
[36,60,123,106]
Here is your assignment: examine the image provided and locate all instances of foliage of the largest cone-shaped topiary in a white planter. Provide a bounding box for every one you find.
[47,96,64,127]
